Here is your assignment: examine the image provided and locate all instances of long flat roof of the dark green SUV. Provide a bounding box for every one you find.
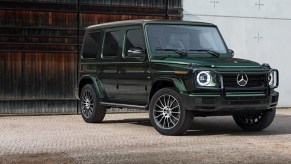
[86,19,216,30]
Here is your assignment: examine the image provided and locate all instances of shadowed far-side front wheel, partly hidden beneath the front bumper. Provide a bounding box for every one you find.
[233,108,276,131]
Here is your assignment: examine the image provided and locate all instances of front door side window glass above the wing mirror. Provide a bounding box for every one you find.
[124,29,145,56]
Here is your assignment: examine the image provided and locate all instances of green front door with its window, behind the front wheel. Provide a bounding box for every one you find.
[118,27,148,105]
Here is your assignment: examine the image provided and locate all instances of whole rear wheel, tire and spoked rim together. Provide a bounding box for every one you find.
[79,84,106,123]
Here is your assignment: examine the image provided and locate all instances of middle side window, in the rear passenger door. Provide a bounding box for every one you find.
[103,31,120,57]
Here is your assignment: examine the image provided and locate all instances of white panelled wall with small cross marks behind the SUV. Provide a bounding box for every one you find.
[183,0,291,107]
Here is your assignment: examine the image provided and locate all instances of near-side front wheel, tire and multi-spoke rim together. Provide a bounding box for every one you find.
[149,88,193,136]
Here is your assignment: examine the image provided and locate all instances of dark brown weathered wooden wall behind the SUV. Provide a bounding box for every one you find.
[0,0,182,114]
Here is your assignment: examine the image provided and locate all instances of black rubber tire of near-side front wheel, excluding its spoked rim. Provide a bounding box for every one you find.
[149,88,193,135]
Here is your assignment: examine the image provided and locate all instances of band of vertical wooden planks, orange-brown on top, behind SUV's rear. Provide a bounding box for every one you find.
[0,52,77,100]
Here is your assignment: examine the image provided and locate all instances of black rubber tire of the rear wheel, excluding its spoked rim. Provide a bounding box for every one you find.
[79,84,106,123]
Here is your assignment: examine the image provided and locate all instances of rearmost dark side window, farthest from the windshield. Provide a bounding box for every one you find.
[82,32,101,58]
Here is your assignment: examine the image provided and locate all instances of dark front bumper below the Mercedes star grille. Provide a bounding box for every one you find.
[182,91,279,112]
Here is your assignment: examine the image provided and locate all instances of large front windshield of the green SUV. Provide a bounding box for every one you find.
[147,24,227,53]
